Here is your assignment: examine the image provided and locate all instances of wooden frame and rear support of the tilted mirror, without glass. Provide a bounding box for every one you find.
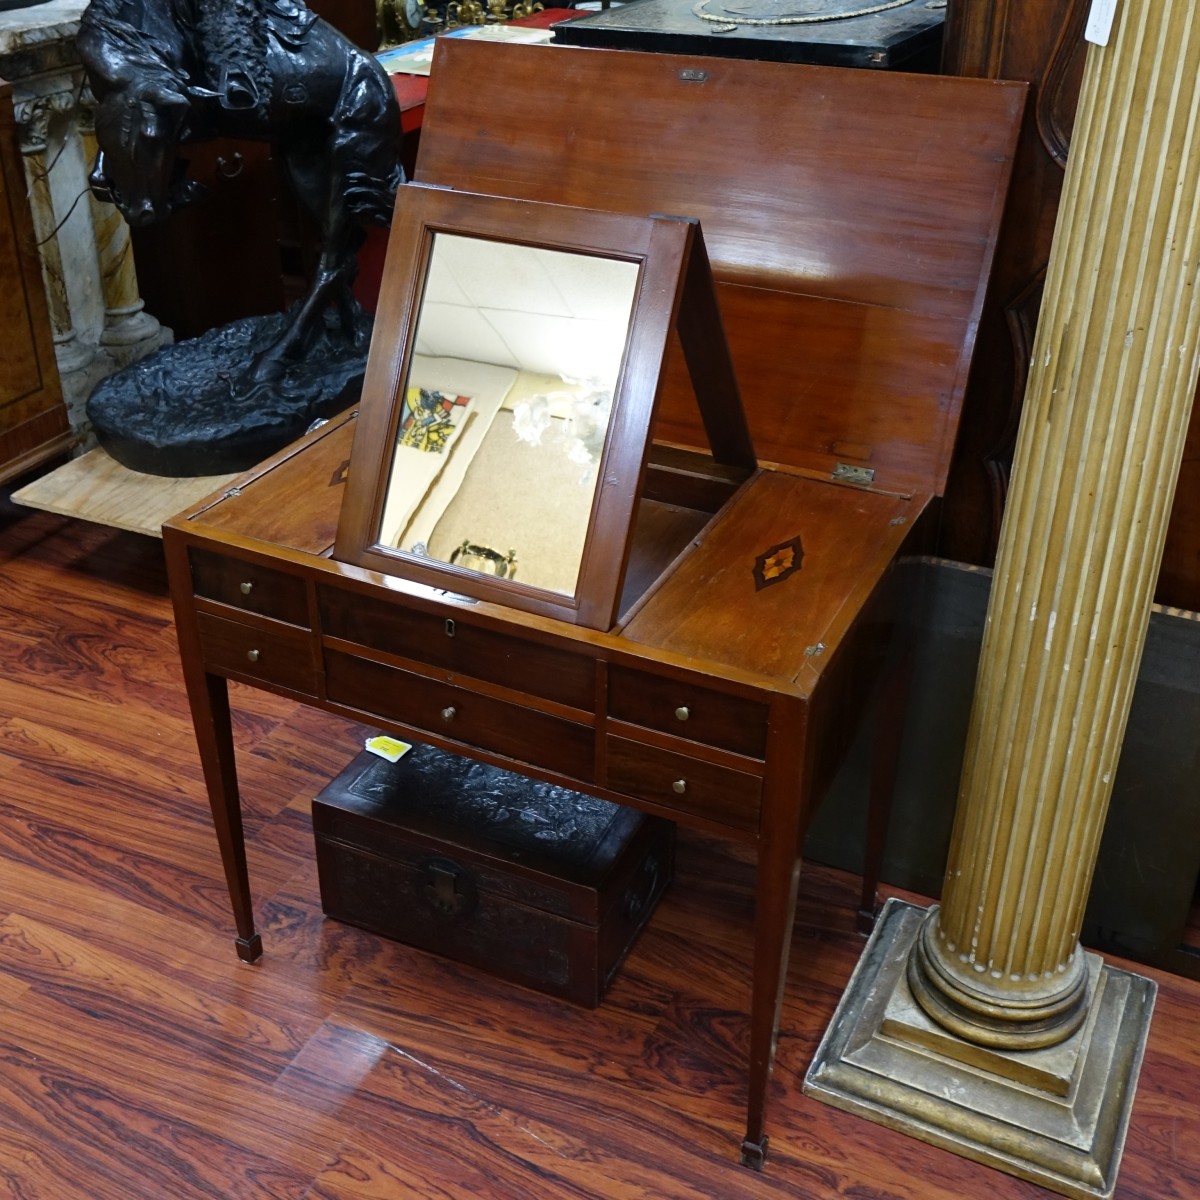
[334,184,754,629]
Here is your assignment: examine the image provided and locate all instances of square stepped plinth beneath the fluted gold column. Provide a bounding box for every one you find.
[804,899,1157,1200]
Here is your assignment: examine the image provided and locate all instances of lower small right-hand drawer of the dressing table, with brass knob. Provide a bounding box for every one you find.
[602,737,762,830]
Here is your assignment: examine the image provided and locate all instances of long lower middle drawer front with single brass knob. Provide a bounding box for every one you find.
[325,650,595,782]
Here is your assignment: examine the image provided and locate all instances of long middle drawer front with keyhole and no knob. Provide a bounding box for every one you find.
[318,588,595,713]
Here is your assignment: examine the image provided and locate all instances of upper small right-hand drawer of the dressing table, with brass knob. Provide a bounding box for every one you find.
[608,666,767,758]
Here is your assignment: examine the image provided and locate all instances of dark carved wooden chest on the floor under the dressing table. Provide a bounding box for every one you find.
[312,745,674,1007]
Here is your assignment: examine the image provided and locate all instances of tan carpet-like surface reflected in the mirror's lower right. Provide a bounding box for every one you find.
[430,412,598,595]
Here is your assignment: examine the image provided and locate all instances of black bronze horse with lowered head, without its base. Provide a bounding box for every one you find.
[77,0,404,389]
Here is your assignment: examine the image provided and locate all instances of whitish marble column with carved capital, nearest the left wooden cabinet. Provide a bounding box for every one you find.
[16,96,95,376]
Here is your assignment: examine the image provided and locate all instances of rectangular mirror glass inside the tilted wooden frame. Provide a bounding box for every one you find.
[377,232,640,596]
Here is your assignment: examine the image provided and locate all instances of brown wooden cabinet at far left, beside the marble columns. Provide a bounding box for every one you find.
[0,80,71,482]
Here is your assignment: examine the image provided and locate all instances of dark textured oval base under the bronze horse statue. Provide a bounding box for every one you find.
[88,310,371,478]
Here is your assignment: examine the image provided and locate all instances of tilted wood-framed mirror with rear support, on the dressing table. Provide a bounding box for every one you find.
[331,184,734,629]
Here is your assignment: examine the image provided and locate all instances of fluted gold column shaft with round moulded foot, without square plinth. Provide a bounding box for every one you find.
[910,0,1200,1046]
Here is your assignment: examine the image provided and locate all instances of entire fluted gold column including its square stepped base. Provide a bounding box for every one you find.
[806,0,1200,1196]
